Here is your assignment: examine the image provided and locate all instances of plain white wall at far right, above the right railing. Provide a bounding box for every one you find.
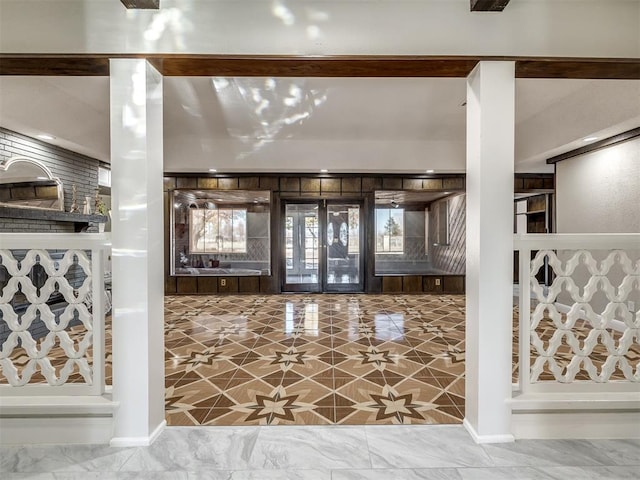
[556,138,640,233]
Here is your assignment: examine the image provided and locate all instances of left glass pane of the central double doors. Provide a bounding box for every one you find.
[284,204,320,284]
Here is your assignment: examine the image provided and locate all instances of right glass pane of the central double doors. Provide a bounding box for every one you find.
[326,204,360,284]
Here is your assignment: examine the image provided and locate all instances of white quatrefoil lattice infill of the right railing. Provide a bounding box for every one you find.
[530,250,640,383]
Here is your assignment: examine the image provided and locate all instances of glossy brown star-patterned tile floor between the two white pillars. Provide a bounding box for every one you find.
[165,294,464,425]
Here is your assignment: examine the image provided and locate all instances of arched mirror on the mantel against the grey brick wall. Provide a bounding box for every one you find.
[0,157,64,211]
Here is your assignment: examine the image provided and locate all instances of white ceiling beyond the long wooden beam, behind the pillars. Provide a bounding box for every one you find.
[0,77,640,173]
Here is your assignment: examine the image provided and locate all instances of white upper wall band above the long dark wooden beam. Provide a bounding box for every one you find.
[0,0,640,58]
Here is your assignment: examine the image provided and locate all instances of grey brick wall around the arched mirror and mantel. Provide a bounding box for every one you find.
[0,127,100,233]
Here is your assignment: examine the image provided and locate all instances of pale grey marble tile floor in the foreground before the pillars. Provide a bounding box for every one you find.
[0,425,640,480]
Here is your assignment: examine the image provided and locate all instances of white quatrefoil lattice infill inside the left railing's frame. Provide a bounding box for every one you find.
[0,250,93,386]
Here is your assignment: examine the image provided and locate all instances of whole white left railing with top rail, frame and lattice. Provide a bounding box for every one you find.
[0,234,110,396]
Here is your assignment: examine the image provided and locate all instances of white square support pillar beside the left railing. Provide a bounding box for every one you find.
[110,59,166,446]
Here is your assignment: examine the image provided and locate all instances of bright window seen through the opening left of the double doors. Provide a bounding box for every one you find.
[189,208,247,253]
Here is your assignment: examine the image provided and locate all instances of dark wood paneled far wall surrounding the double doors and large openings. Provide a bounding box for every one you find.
[164,173,554,294]
